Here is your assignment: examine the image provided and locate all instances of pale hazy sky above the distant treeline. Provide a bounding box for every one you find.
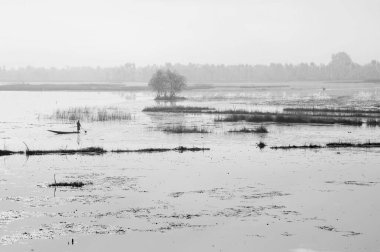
[0,0,380,67]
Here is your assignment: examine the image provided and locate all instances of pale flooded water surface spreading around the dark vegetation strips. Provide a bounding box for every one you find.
[0,81,380,252]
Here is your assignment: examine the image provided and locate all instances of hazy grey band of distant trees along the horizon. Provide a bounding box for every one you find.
[0,52,380,83]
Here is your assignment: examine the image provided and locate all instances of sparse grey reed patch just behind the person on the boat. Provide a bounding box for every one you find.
[49,107,132,122]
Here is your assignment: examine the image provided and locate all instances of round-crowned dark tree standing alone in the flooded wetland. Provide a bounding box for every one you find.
[148,70,186,100]
